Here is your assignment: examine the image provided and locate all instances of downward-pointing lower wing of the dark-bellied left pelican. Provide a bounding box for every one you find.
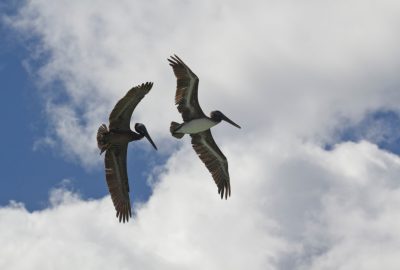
[104,144,132,223]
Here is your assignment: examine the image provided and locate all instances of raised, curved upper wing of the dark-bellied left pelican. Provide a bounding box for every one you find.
[109,82,153,131]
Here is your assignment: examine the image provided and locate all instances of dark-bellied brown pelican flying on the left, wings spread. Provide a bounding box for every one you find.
[97,82,157,223]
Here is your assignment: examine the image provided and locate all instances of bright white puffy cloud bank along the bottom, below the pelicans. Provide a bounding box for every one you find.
[0,142,400,269]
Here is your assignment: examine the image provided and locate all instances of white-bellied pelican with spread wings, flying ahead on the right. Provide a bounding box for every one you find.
[168,55,240,199]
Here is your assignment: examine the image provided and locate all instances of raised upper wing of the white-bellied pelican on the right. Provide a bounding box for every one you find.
[168,55,205,122]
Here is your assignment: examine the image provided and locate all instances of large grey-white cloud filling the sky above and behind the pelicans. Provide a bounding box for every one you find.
[5,0,400,164]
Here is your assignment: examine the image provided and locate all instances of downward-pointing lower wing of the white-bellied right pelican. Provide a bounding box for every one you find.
[190,130,231,199]
